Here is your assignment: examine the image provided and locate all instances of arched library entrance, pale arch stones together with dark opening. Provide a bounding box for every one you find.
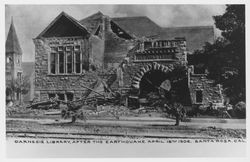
[131,62,190,104]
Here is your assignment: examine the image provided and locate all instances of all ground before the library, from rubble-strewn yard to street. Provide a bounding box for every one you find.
[6,105,246,139]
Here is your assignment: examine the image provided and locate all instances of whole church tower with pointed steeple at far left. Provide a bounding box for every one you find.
[5,19,23,102]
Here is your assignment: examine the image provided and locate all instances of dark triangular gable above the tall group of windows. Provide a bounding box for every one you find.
[38,12,89,38]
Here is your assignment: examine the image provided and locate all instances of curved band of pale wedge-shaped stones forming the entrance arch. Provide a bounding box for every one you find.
[132,62,174,89]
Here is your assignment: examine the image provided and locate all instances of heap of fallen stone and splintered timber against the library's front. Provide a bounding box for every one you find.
[27,74,127,122]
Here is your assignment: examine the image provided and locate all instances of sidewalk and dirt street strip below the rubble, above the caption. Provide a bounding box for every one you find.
[6,119,246,139]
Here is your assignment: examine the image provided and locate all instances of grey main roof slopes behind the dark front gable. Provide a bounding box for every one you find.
[80,12,214,52]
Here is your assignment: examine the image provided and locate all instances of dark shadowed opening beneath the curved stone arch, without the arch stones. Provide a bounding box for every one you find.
[139,70,190,105]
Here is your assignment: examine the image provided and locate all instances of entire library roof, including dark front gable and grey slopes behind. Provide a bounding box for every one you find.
[35,11,214,52]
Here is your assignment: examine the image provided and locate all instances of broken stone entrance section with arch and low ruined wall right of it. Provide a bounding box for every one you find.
[114,38,223,106]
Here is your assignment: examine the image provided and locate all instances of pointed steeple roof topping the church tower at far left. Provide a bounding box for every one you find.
[5,18,22,54]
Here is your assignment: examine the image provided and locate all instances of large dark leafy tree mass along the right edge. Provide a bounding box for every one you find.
[189,5,245,104]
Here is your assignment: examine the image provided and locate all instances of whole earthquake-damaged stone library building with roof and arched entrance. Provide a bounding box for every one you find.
[33,12,223,105]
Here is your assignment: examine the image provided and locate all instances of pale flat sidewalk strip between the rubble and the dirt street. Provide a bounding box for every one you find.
[6,117,246,129]
